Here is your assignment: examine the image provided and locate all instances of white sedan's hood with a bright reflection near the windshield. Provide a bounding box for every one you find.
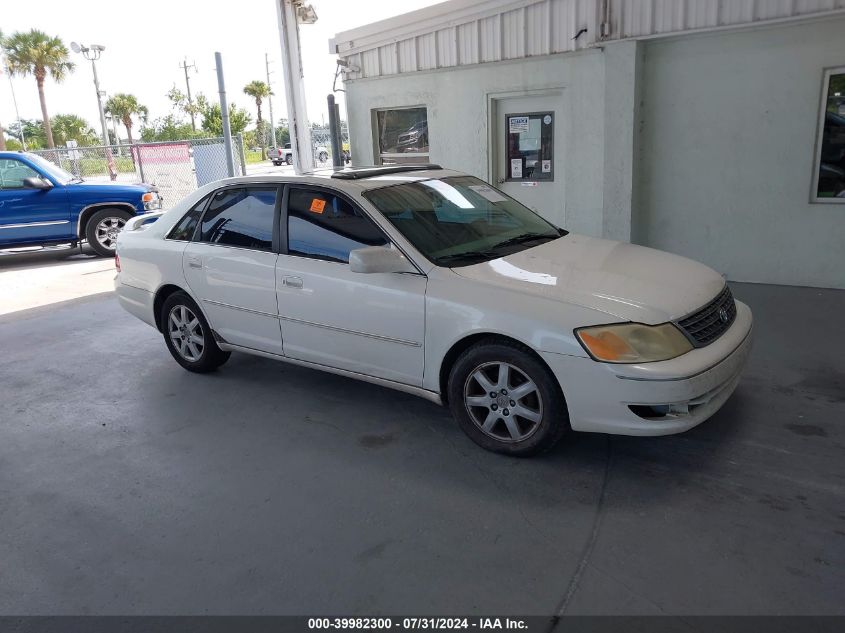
[452,233,725,324]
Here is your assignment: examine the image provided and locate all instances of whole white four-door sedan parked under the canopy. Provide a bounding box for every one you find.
[115,165,752,455]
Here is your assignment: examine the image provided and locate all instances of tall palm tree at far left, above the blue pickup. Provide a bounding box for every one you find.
[0,29,74,149]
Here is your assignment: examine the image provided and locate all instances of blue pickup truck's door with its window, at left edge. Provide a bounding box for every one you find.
[0,158,70,247]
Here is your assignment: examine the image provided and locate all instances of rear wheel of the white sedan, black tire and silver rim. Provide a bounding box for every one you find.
[160,291,232,374]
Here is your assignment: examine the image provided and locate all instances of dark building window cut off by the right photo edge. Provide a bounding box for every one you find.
[813,67,845,203]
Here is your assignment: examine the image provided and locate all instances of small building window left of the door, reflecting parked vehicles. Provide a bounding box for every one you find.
[375,107,429,165]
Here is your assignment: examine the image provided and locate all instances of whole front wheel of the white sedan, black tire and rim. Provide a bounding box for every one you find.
[448,339,570,457]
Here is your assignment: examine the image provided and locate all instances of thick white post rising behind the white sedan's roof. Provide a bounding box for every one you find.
[274,0,317,174]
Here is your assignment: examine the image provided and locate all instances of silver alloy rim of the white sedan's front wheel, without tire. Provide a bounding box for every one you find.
[464,362,543,442]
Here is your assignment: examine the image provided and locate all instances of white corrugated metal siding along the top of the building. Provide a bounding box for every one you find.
[337,0,845,79]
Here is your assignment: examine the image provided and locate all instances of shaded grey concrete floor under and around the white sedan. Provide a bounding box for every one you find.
[0,270,845,615]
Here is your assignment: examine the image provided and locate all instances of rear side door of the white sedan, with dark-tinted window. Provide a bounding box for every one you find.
[182,185,282,355]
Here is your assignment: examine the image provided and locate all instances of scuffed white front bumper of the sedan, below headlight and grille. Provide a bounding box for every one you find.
[542,301,753,435]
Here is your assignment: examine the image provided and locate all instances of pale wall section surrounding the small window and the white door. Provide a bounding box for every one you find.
[346,50,615,235]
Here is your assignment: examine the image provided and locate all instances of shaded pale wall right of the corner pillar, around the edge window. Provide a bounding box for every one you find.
[632,18,845,288]
